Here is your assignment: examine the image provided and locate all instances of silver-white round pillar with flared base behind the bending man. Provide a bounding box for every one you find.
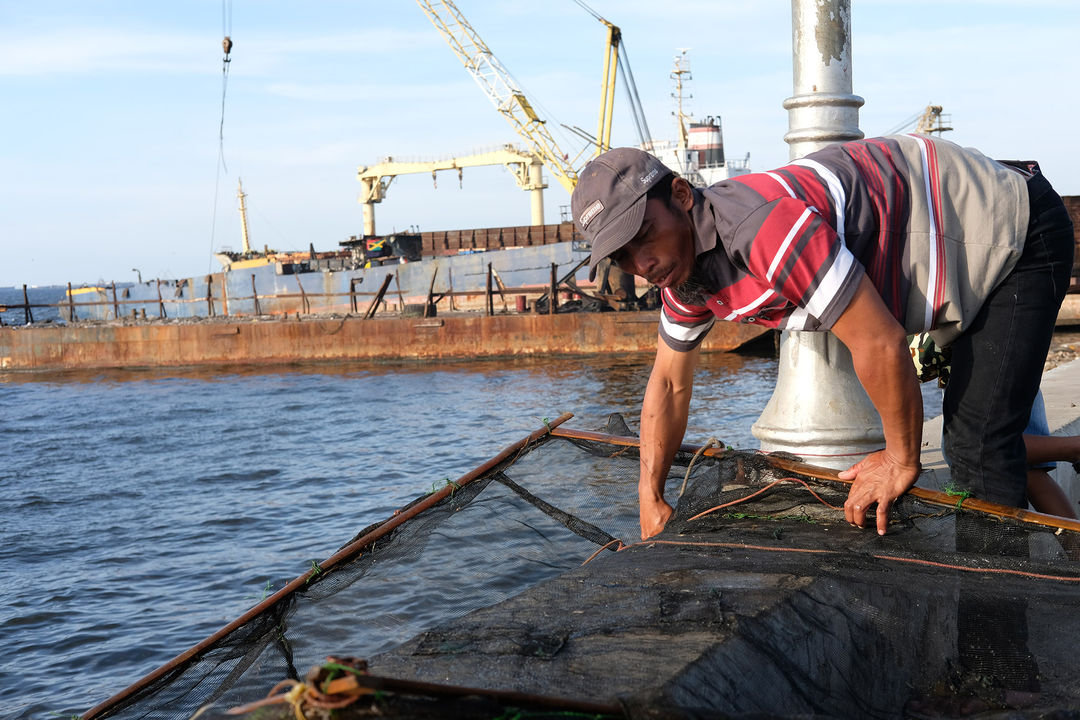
[752,0,885,468]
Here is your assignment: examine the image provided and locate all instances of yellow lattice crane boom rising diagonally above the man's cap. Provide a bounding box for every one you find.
[417,0,578,192]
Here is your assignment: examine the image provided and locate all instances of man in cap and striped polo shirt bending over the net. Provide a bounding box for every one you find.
[571,135,1072,539]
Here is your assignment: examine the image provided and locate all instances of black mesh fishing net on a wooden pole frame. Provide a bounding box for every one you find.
[83,418,1080,720]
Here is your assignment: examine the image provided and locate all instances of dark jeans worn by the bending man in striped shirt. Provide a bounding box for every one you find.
[942,173,1074,507]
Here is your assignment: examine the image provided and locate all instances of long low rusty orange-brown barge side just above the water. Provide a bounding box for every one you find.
[0,311,771,371]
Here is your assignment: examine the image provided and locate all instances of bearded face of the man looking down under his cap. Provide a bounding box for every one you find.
[611,180,694,287]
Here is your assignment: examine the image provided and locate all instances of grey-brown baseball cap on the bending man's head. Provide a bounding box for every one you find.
[570,148,671,279]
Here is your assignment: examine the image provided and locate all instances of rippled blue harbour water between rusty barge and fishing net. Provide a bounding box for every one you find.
[0,330,934,718]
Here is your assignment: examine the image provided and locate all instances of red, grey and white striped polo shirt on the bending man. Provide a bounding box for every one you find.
[660,135,1028,351]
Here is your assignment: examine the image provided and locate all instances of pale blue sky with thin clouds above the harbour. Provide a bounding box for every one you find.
[0,0,1080,285]
